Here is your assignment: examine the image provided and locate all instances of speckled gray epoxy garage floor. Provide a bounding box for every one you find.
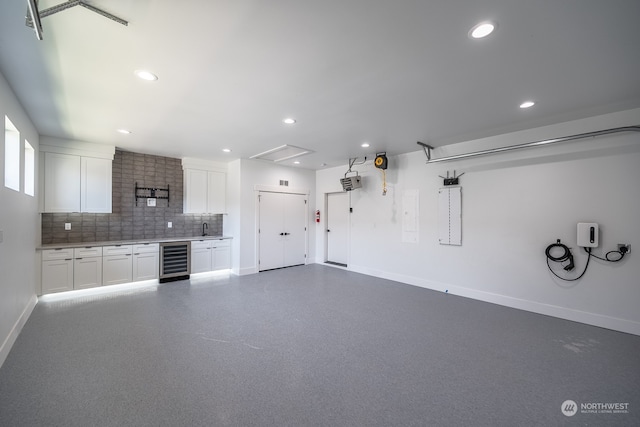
[0,265,640,426]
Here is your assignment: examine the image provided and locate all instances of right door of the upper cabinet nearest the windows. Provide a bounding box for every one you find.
[80,157,113,213]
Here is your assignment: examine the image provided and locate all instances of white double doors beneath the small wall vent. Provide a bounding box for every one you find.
[258,192,307,271]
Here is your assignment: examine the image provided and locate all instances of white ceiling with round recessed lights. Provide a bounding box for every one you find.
[0,0,640,169]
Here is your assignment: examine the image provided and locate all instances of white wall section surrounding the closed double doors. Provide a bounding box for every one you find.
[236,159,316,275]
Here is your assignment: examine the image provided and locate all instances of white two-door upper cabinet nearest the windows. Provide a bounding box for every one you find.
[40,139,115,213]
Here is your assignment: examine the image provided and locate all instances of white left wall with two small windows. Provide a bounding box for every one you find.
[0,70,40,366]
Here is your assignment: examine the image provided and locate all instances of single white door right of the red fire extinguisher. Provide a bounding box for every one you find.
[327,193,349,266]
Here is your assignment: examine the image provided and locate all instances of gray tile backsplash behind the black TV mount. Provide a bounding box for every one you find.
[42,150,223,244]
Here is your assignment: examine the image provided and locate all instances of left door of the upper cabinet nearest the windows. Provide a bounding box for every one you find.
[44,153,80,212]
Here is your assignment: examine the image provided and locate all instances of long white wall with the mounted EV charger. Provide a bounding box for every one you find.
[316,110,640,335]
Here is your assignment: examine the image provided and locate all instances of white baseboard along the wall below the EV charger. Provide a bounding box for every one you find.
[349,265,640,335]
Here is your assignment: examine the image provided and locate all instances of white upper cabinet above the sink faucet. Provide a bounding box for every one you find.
[182,158,227,214]
